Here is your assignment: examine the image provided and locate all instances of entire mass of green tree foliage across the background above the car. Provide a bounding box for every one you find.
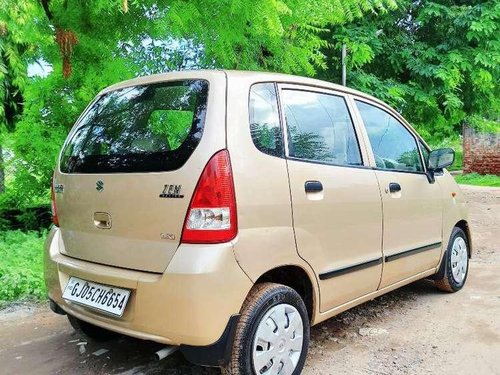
[0,0,500,208]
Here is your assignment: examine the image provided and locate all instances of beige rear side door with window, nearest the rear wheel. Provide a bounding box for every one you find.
[280,85,382,312]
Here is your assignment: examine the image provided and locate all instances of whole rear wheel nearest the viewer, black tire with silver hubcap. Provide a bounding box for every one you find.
[223,283,309,375]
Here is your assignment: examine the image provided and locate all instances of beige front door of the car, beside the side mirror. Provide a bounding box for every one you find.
[355,98,442,288]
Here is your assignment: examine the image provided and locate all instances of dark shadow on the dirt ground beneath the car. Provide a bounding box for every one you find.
[82,280,443,375]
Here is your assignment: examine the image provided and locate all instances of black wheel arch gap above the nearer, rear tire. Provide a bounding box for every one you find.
[255,265,317,322]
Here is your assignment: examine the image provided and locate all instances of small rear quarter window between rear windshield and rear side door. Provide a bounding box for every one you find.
[249,83,284,156]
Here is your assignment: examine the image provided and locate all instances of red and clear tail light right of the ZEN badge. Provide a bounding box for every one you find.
[181,150,238,243]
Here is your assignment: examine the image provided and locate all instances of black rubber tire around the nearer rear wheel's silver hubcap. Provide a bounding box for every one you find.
[222,283,310,375]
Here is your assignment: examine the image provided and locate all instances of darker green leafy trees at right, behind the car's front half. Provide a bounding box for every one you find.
[322,0,500,142]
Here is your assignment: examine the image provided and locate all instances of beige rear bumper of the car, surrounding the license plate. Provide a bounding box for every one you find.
[44,228,252,348]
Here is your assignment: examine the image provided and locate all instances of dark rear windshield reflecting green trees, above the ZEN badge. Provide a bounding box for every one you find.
[60,80,208,173]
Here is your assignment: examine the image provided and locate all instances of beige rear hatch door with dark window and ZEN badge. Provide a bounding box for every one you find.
[54,72,226,272]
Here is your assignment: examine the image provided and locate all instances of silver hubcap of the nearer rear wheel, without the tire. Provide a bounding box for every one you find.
[252,304,304,375]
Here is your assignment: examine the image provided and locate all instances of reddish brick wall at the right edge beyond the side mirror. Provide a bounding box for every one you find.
[463,126,500,176]
